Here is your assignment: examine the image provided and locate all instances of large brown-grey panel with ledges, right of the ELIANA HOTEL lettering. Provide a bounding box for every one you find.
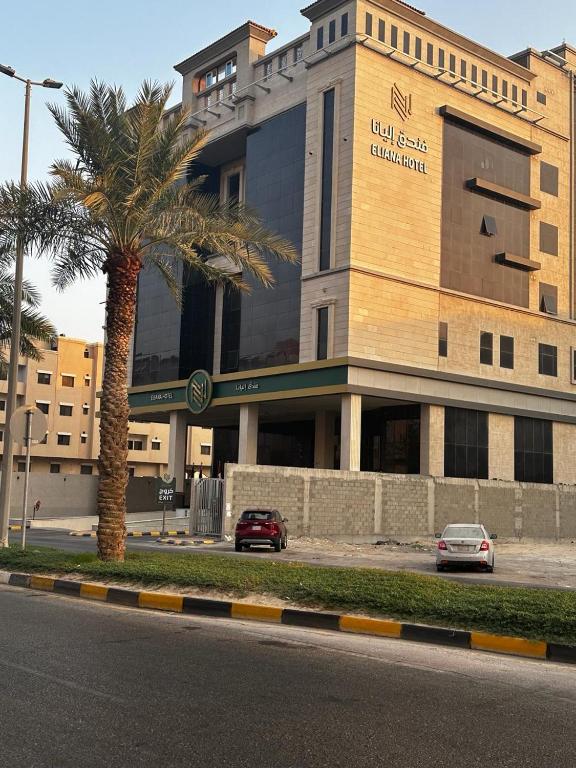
[441,120,530,307]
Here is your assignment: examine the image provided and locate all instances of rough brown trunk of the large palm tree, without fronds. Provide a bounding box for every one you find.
[97,254,141,561]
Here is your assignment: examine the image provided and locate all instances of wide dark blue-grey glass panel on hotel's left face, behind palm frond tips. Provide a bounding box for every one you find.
[234,104,306,371]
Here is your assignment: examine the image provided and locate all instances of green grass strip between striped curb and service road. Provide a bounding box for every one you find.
[0,547,576,645]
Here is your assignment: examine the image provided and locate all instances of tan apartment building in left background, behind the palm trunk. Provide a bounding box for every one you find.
[0,336,212,477]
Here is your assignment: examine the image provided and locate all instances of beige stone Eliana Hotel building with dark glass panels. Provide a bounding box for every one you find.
[129,0,576,498]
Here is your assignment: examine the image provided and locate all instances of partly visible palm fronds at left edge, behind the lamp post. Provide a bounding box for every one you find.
[0,253,56,370]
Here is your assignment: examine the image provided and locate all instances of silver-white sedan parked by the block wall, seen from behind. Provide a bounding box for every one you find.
[436,523,498,573]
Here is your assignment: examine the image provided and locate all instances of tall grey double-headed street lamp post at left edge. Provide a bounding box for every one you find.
[0,64,62,547]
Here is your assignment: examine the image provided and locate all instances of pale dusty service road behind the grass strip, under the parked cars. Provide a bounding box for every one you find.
[10,529,576,591]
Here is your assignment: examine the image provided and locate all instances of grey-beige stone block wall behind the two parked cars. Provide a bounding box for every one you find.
[225,464,576,541]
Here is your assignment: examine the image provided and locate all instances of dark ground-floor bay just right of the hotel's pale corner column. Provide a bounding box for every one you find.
[360,405,420,475]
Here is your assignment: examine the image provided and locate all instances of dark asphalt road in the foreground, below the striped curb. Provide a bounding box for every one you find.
[0,587,576,768]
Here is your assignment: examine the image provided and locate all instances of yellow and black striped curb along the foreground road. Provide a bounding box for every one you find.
[0,571,576,664]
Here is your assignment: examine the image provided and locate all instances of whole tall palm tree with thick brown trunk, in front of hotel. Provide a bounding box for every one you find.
[0,82,297,560]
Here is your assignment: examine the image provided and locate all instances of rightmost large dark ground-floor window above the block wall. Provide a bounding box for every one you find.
[514,416,554,483]
